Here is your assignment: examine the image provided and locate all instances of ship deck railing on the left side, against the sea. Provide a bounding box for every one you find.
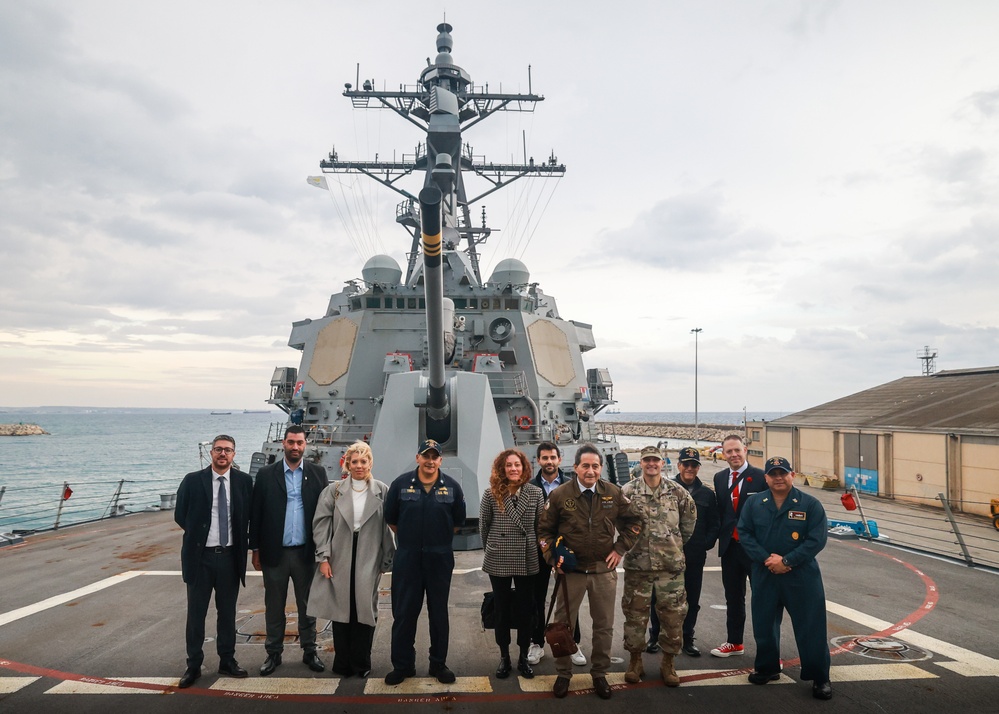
[0,477,180,535]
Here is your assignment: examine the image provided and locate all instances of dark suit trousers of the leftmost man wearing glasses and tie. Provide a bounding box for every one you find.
[186,548,239,669]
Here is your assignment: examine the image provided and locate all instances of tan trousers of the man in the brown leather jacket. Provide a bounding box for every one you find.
[555,570,617,678]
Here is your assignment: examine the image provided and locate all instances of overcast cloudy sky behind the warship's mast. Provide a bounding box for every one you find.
[0,0,999,412]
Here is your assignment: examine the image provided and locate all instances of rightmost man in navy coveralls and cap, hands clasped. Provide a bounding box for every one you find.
[739,456,832,699]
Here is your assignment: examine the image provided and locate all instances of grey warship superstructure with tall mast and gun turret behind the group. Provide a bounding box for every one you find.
[251,23,627,544]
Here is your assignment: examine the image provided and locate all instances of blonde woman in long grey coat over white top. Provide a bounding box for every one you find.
[309,442,395,677]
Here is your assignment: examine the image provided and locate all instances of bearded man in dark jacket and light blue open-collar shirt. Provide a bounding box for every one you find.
[250,425,329,677]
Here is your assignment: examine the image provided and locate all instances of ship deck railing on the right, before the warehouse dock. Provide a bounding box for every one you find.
[826,485,999,570]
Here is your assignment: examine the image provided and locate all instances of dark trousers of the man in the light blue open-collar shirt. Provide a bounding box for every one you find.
[263,546,316,655]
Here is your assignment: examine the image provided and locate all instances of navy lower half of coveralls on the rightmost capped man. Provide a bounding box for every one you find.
[752,562,829,684]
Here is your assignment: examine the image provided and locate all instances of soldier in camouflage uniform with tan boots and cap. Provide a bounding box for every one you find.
[621,446,697,687]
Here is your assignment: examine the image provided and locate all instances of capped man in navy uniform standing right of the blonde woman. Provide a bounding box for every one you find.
[385,439,465,684]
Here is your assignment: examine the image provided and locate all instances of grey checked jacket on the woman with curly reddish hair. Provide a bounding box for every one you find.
[479,483,545,577]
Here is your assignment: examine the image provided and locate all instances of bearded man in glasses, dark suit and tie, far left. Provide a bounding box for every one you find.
[173,434,253,689]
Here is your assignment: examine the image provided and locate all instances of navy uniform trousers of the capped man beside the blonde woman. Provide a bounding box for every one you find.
[392,548,454,672]
